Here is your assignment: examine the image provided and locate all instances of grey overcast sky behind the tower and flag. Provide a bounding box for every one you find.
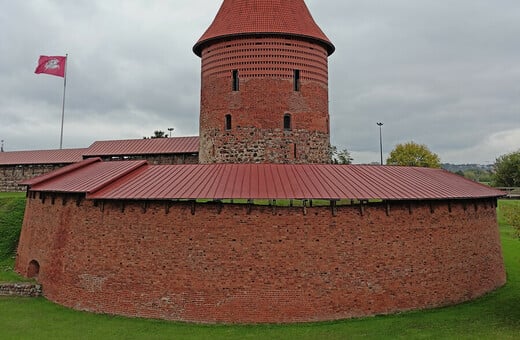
[0,0,520,164]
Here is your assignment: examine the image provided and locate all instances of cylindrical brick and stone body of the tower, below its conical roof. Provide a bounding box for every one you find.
[199,36,330,163]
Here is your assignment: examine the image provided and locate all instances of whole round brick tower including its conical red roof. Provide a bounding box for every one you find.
[193,0,334,163]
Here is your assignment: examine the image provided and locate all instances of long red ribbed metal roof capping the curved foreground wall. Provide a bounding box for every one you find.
[25,162,504,200]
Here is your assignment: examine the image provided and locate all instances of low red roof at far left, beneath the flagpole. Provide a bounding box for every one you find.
[0,149,87,165]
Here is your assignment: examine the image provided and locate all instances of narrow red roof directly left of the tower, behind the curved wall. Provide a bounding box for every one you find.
[83,137,199,157]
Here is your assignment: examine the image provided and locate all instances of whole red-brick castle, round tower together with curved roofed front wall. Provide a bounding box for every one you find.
[16,0,506,323]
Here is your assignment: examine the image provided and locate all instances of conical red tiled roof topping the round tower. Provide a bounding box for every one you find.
[193,0,334,56]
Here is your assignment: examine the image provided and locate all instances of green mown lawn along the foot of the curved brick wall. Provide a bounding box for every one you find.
[0,200,520,339]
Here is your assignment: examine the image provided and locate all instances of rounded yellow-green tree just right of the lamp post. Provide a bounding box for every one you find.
[386,142,441,168]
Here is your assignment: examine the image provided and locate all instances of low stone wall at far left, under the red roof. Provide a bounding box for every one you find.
[0,164,67,192]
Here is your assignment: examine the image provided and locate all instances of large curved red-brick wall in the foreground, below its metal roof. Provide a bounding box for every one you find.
[16,195,506,323]
